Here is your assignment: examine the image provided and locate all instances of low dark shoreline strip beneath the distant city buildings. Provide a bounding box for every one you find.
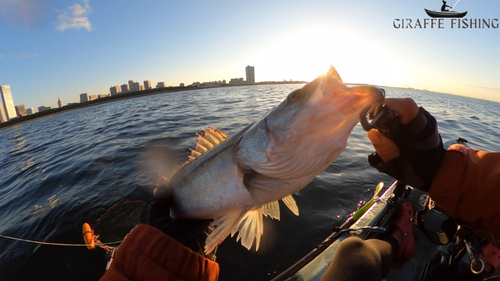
[0,81,308,130]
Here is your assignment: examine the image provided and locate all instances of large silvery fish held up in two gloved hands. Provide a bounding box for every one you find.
[161,66,384,253]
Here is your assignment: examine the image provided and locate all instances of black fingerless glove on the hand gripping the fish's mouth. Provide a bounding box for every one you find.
[368,108,445,191]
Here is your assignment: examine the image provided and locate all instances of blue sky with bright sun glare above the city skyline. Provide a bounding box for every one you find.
[0,0,500,111]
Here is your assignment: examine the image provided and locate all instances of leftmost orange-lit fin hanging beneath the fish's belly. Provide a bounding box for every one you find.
[205,210,245,254]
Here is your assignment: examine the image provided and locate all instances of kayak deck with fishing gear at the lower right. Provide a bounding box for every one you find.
[272,139,500,281]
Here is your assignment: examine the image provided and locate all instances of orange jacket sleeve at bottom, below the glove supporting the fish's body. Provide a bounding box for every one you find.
[100,224,219,281]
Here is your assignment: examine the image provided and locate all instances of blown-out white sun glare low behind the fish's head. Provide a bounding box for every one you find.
[256,26,397,84]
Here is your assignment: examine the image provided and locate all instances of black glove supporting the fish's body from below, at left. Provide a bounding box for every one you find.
[139,194,215,260]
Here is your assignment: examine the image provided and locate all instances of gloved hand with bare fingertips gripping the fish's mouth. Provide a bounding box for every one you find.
[367,98,445,191]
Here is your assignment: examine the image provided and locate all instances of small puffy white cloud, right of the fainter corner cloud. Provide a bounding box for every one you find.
[56,0,92,31]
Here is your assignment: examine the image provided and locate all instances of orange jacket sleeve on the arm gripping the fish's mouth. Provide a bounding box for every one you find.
[429,145,500,246]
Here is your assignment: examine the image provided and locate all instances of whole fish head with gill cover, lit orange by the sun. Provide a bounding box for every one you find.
[238,67,384,185]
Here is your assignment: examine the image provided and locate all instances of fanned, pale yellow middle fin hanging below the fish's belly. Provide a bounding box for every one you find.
[231,207,264,251]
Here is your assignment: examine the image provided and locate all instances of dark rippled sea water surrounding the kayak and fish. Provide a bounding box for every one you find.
[0,85,500,280]
